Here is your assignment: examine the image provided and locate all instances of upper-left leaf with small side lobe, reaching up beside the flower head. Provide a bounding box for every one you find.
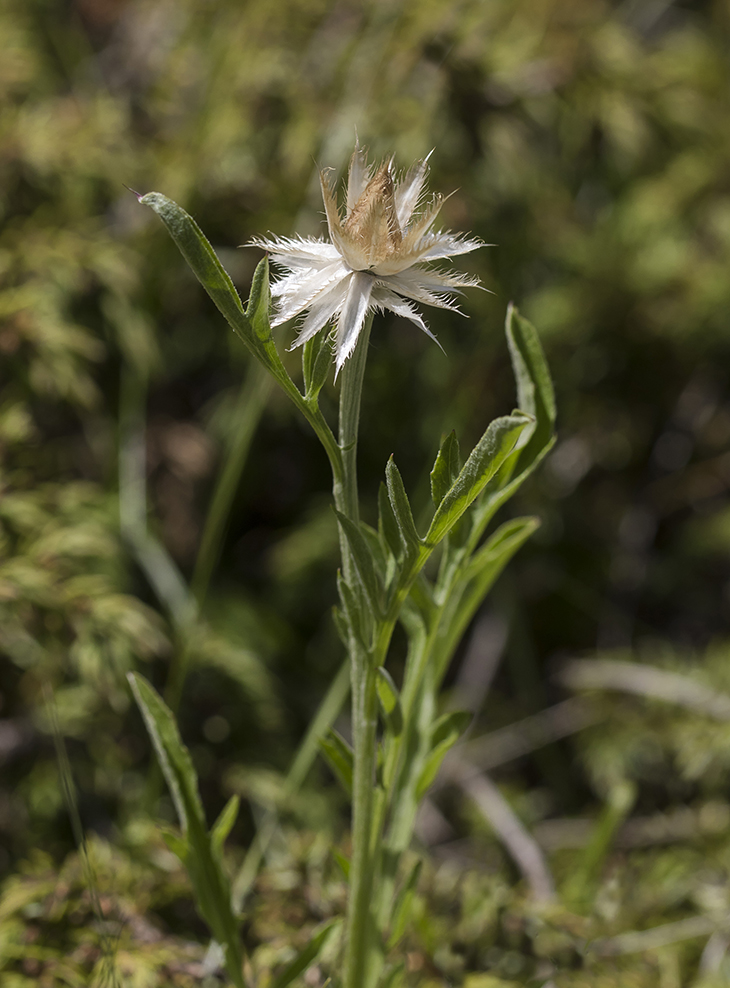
[139,192,293,388]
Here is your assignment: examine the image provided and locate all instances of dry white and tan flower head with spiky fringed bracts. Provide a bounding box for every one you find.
[252,145,482,376]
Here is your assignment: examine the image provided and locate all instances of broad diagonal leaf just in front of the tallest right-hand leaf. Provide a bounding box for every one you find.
[426,411,534,545]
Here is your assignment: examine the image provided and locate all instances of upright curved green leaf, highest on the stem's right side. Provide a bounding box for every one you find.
[505,304,556,469]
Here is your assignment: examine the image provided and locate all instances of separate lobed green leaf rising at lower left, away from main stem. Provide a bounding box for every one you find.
[127,673,245,988]
